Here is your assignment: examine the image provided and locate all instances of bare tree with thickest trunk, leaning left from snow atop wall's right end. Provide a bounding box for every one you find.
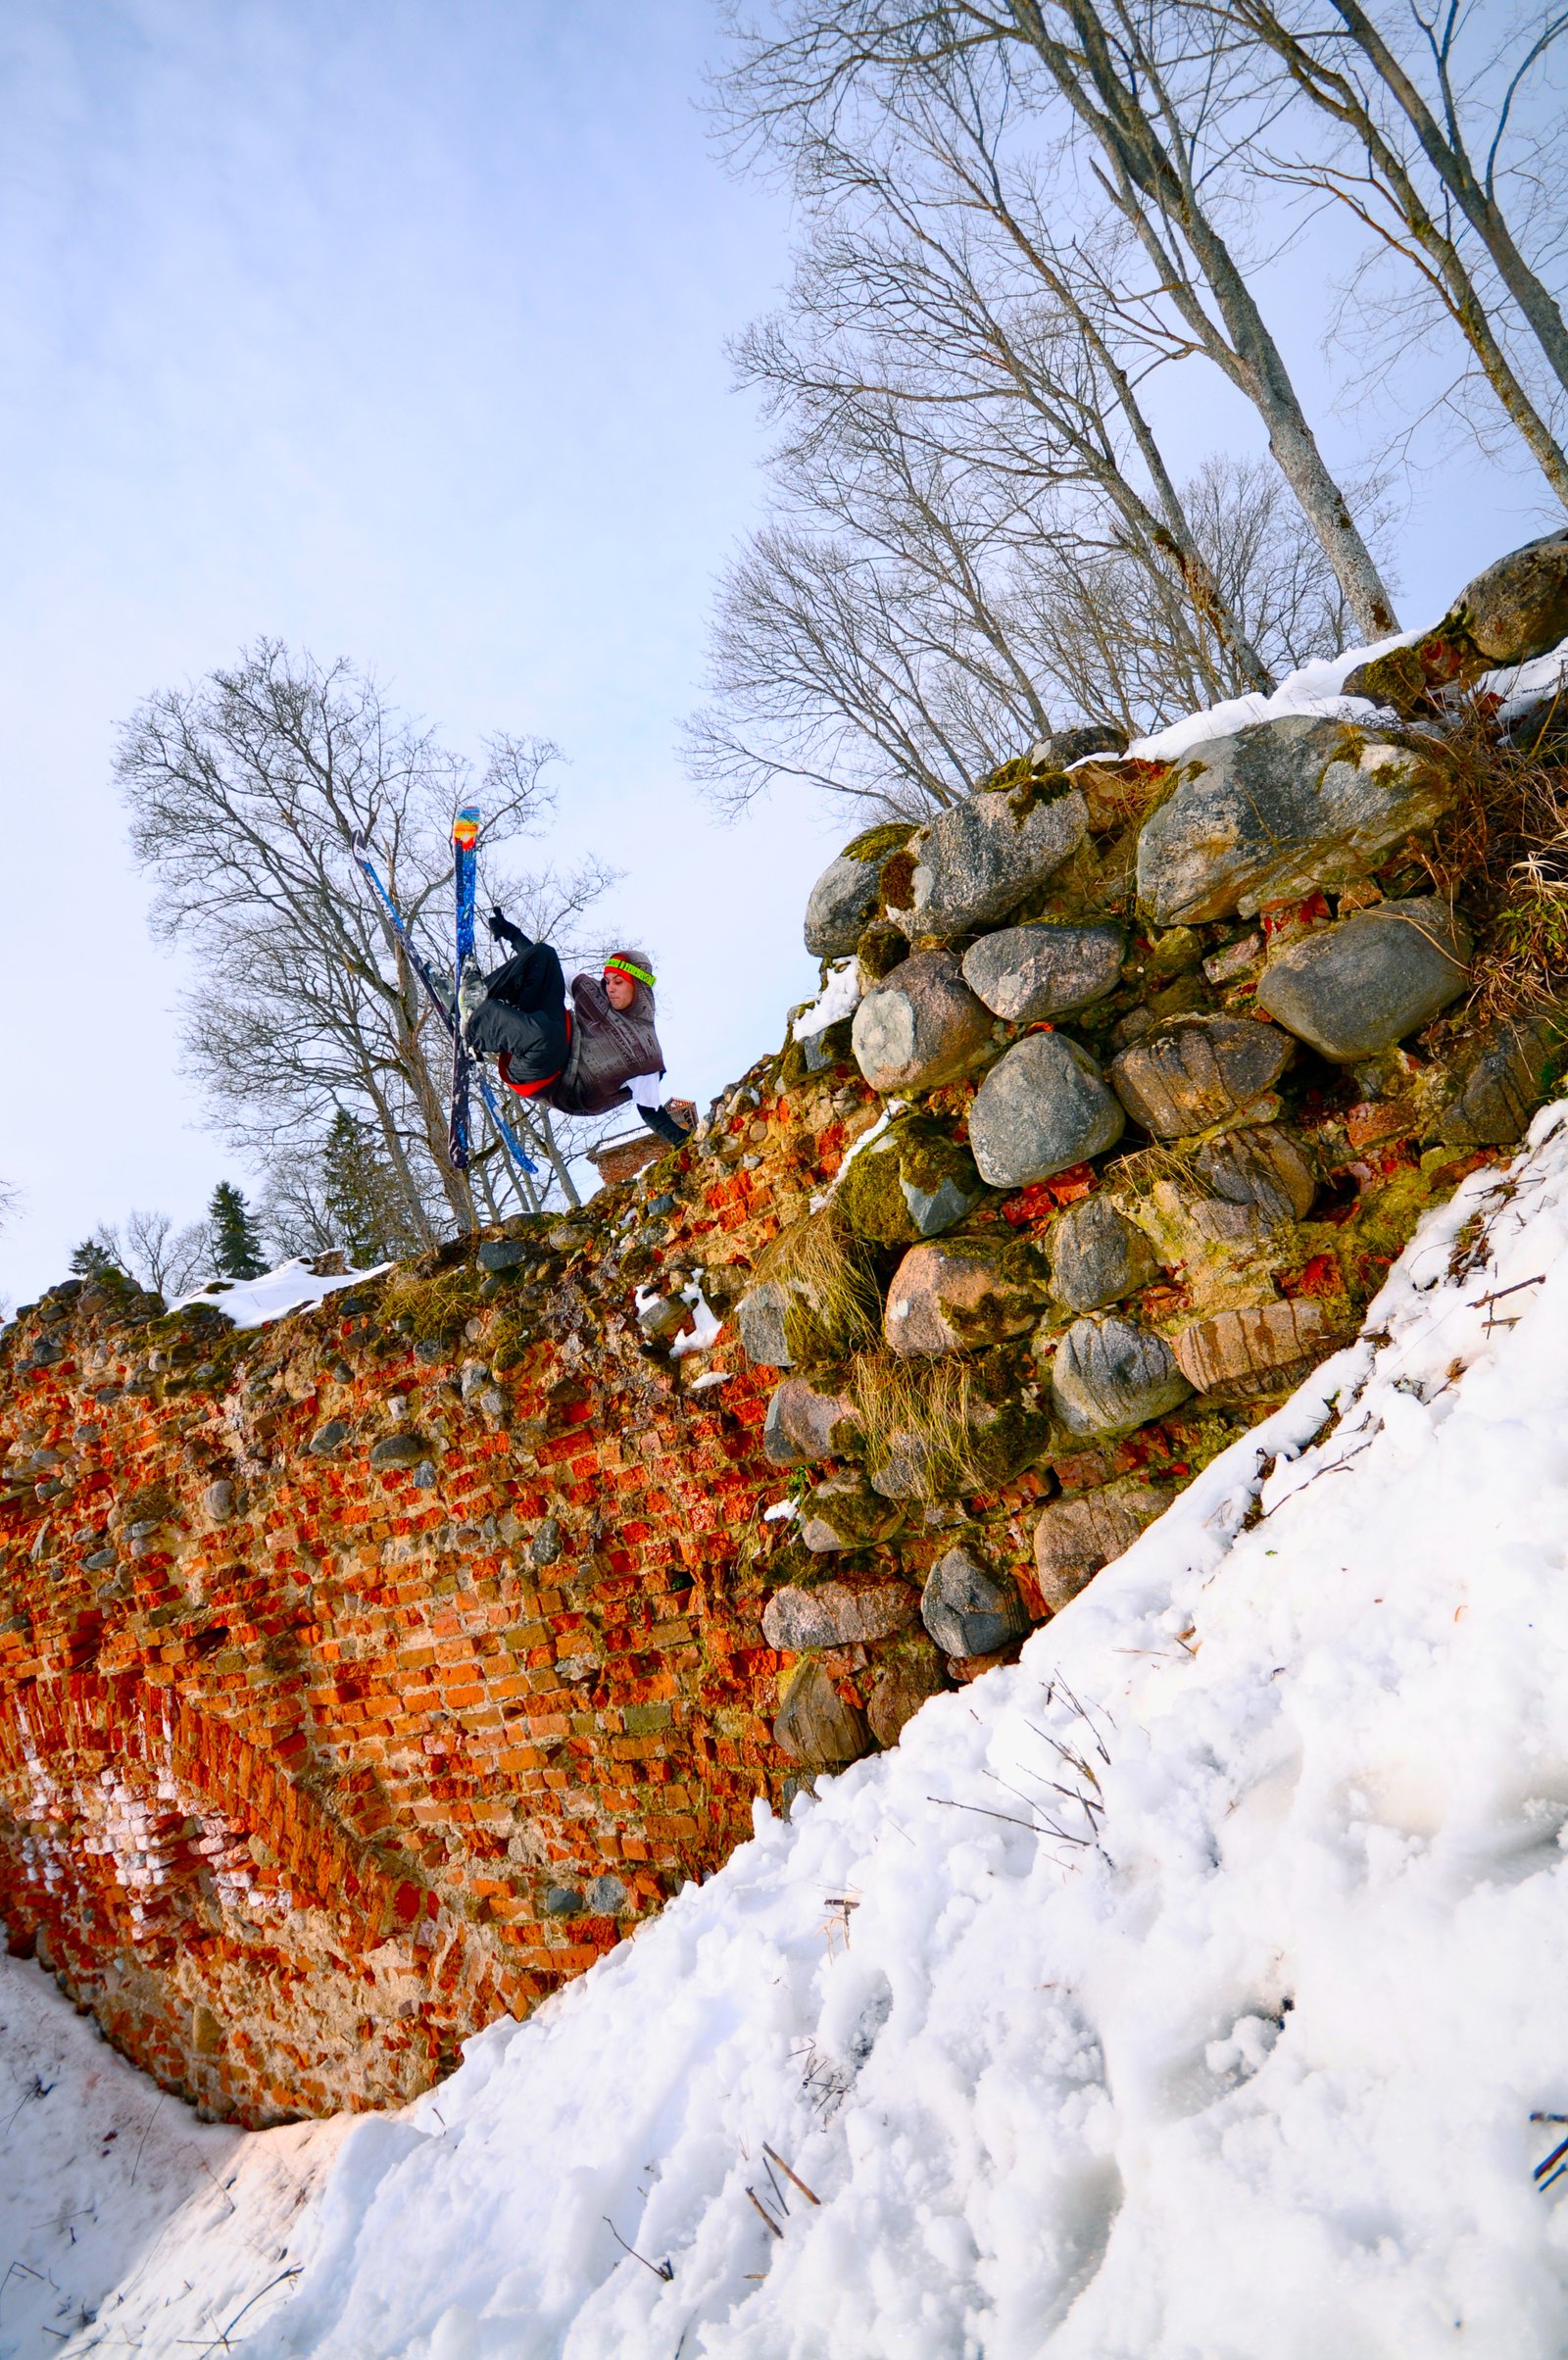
[722,0,1396,635]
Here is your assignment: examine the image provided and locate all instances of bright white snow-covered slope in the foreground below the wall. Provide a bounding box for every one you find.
[33,1106,1568,2360]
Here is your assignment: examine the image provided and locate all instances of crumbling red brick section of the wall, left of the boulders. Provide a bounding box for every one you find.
[0,1080,838,2124]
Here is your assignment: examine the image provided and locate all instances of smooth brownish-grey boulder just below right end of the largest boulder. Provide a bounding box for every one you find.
[1258,897,1471,1064]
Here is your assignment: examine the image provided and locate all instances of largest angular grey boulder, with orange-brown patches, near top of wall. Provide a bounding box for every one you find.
[1138,713,1454,925]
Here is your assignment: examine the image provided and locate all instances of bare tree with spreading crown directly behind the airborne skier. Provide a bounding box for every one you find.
[116,640,610,1244]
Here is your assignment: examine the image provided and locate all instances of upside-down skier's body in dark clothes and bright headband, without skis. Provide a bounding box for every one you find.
[458,909,697,1147]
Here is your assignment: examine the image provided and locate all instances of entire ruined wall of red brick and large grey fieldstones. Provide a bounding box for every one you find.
[0,525,1568,2124]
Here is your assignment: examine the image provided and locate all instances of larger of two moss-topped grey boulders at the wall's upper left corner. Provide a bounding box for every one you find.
[888,779,1089,939]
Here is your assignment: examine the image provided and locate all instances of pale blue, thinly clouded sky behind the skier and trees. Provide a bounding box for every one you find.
[0,0,1542,1301]
